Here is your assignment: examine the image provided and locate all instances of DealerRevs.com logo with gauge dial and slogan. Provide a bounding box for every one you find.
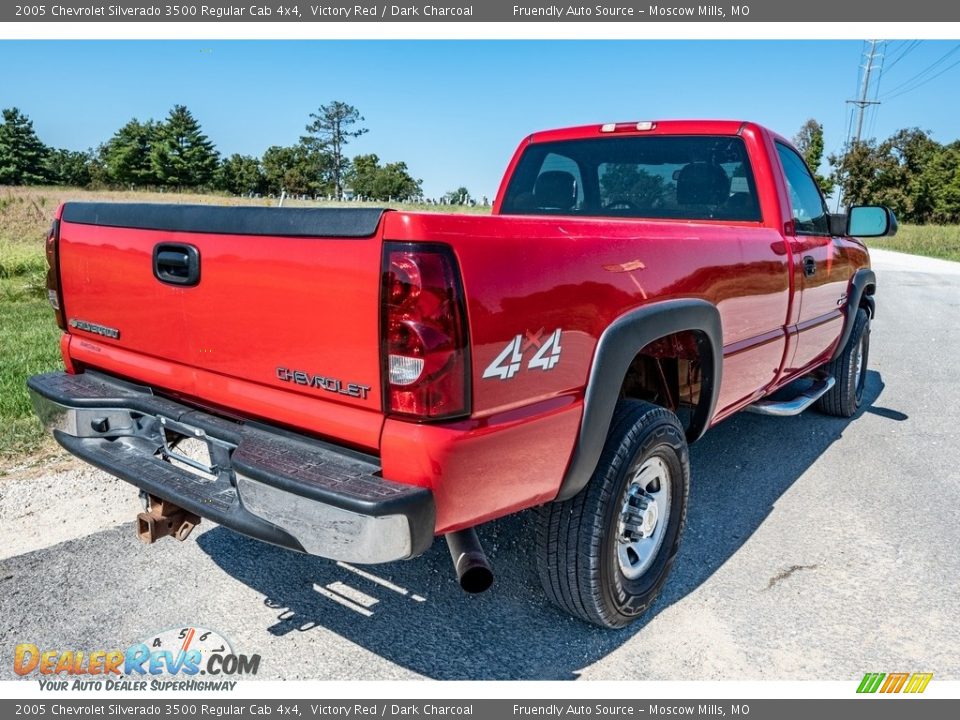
[13,627,260,691]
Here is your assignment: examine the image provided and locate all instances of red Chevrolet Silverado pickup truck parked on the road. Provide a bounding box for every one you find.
[28,121,896,627]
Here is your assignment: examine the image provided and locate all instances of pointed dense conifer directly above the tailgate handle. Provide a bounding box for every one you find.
[150,105,220,189]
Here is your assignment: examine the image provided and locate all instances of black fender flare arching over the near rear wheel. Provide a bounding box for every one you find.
[555,298,723,501]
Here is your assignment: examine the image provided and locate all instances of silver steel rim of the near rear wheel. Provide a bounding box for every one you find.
[616,457,671,580]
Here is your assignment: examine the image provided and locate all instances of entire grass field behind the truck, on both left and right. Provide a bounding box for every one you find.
[0,188,960,457]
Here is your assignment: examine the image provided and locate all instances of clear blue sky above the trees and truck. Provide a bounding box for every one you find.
[0,40,960,198]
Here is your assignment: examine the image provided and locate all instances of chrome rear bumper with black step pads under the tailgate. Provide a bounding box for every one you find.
[27,372,436,563]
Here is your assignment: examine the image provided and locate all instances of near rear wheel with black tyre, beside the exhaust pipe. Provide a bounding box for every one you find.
[537,400,690,628]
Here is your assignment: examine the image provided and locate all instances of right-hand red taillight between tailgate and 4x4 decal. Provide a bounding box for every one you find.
[381,243,470,420]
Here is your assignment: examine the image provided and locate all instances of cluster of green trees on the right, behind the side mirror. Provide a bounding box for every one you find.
[794,120,960,225]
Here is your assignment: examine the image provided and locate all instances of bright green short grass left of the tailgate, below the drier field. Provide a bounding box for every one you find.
[0,275,62,458]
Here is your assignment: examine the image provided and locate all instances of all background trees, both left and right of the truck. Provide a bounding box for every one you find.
[0,101,960,219]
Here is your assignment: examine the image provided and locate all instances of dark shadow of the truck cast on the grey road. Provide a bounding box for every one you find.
[197,372,906,680]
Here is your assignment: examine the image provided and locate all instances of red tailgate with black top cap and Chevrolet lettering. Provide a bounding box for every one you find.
[60,203,383,446]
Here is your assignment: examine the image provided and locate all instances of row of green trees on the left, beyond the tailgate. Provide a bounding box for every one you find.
[0,101,442,201]
